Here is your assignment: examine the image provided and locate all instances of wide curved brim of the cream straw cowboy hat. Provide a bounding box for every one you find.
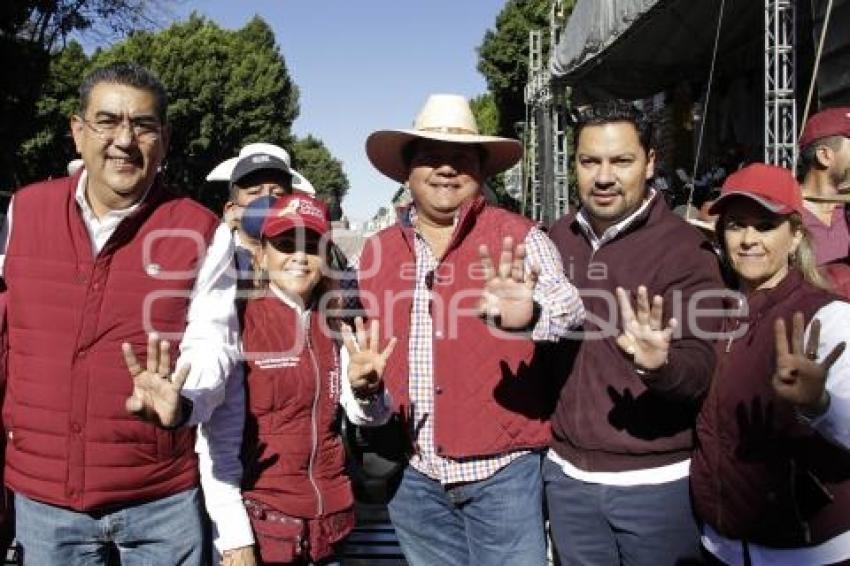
[366,130,522,183]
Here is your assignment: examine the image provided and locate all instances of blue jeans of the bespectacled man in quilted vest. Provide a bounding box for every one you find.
[15,488,206,566]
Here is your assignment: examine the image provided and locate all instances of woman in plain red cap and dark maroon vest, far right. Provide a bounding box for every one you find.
[691,164,850,565]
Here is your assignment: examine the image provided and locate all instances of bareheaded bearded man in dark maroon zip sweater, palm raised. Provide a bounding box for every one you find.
[543,101,723,565]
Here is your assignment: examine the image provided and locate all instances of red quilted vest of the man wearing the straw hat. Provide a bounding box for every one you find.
[359,198,556,458]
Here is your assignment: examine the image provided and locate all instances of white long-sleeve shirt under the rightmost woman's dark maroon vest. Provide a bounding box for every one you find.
[702,301,850,566]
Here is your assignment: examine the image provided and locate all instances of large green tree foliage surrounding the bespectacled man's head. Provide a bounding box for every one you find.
[13,14,308,216]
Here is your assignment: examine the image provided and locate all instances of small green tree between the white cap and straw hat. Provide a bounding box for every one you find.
[291,135,349,220]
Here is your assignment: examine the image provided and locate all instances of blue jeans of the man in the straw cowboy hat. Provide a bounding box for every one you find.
[389,453,546,566]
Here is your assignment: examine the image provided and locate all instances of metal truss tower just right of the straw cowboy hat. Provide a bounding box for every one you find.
[522,0,569,226]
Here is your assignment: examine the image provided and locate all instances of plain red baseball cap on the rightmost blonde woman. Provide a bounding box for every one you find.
[708,163,803,219]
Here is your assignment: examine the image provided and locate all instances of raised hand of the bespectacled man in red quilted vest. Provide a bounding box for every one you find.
[121,333,189,428]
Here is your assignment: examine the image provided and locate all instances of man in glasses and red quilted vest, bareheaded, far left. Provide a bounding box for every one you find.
[0,63,237,565]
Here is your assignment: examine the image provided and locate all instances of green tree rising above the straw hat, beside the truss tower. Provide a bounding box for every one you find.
[478,0,575,137]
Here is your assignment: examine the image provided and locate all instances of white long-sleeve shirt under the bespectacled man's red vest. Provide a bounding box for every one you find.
[0,172,239,425]
